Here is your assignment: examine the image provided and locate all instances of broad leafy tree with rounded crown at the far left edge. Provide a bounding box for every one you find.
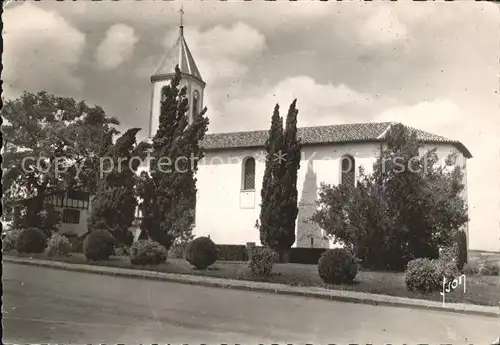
[1,91,118,227]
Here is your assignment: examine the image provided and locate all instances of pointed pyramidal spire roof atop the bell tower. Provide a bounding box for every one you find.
[151,26,203,81]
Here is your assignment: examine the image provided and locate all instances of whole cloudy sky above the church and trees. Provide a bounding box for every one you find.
[2,1,500,251]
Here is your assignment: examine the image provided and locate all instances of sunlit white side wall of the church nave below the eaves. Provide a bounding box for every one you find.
[195,143,380,247]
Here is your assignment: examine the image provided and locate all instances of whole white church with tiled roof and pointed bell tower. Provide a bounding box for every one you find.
[142,23,472,248]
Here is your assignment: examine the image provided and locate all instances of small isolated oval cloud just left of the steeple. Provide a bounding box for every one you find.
[96,24,139,69]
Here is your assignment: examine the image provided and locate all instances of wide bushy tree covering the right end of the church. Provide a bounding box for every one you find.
[312,125,468,270]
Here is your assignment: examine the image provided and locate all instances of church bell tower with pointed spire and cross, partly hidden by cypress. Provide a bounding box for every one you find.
[149,9,206,138]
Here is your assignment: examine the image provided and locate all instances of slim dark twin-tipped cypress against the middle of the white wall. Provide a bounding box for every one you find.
[257,100,300,259]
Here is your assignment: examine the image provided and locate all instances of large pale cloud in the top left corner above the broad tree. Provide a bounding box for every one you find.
[2,3,86,98]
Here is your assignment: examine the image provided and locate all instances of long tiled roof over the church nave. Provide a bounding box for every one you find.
[201,122,472,158]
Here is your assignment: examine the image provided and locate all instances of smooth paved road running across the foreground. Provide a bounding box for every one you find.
[3,263,500,344]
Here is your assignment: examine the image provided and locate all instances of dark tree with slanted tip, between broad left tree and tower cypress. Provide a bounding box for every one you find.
[90,128,145,245]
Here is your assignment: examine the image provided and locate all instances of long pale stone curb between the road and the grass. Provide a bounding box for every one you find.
[3,257,500,318]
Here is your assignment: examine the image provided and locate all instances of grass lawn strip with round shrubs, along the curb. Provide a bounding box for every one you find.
[6,252,500,306]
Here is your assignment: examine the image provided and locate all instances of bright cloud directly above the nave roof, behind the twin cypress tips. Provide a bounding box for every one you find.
[209,76,380,132]
